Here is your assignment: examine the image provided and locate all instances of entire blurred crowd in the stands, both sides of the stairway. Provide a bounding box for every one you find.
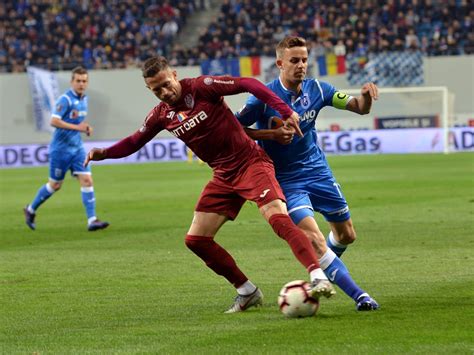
[0,0,474,72]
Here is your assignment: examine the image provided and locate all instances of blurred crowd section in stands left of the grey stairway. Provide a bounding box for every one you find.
[0,0,205,72]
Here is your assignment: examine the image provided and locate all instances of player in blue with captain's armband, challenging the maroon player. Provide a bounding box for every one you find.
[236,37,379,311]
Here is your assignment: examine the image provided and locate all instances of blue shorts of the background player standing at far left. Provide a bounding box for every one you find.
[49,149,91,181]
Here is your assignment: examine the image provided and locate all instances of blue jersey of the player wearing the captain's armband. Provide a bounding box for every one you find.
[236,78,336,183]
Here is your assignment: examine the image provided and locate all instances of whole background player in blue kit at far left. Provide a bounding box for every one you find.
[23,67,109,231]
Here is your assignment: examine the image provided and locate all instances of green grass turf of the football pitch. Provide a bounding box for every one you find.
[0,153,474,354]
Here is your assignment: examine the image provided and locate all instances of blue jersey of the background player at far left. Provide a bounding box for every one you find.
[49,89,87,153]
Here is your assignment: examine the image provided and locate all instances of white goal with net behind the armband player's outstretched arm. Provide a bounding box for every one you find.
[317,86,454,153]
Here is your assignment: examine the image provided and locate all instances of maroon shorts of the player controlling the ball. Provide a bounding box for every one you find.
[196,158,285,220]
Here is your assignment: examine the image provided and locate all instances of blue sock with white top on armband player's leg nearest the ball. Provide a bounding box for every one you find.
[319,248,365,301]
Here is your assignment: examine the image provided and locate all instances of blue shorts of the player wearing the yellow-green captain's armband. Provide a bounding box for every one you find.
[281,176,351,224]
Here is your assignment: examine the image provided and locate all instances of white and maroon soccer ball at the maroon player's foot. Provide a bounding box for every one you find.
[278,280,319,318]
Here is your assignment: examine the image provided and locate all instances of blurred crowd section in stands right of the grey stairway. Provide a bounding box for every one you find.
[195,0,474,58]
